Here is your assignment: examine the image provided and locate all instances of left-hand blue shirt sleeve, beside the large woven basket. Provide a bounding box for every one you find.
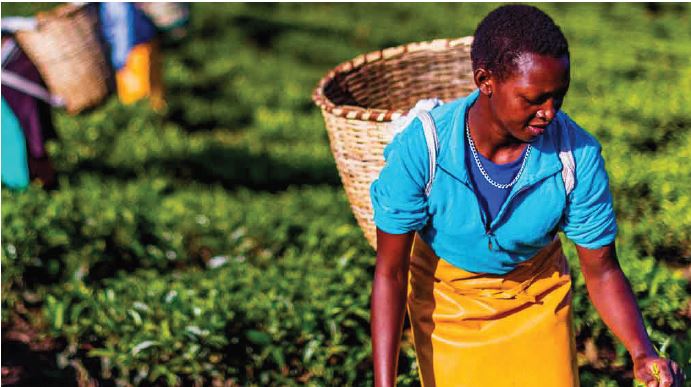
[370,118,429,234]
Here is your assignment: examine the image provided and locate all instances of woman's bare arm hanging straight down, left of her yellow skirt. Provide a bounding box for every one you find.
[370,228,415,387]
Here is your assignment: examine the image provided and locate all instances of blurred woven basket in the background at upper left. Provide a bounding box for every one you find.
[15,4,112,114]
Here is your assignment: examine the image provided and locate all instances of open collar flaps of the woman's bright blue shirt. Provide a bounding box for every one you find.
[438,89,561,189]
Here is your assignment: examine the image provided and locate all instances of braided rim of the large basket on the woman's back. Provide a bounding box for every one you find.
[312,36,473,122]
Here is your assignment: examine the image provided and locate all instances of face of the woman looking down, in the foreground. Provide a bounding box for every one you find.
[489,53,570,142]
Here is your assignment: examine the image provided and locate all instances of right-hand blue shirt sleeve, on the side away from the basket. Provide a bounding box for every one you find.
[562,120,617,249]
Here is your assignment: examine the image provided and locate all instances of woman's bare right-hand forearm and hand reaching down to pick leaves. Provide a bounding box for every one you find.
[576,243,683,387]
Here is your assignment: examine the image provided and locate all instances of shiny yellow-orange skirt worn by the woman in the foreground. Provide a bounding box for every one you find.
[408,235,579,387]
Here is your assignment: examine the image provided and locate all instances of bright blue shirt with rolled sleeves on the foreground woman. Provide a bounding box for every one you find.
[370,90,617,274]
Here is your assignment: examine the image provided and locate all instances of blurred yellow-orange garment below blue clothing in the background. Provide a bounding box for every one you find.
[115,41,165,110]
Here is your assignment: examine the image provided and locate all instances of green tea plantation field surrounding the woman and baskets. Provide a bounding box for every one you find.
[2,3,691,386]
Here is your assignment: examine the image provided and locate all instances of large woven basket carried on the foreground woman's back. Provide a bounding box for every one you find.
[312,37,475,249]
